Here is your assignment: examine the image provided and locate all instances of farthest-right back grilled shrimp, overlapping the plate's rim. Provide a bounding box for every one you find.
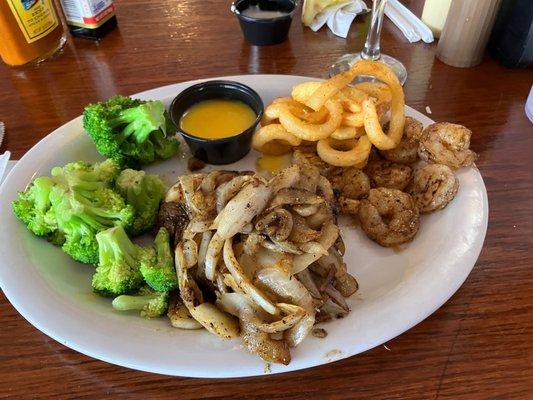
[418,122,477,169]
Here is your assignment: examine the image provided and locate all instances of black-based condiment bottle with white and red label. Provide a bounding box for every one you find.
[60,0,117,40]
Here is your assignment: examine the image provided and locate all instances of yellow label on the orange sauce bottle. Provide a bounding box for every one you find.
[7,0,59,43]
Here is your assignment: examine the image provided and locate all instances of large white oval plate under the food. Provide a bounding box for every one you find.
[0,75,488,378]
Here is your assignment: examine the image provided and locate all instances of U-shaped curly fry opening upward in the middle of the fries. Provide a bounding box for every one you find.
[279,100,342,141]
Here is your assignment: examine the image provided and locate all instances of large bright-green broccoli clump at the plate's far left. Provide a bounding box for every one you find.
[13,160,134,264]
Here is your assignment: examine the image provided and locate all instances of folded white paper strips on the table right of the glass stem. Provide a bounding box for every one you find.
[385,0,434,43]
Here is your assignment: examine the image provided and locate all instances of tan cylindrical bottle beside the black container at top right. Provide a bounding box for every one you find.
[437,0,501,68]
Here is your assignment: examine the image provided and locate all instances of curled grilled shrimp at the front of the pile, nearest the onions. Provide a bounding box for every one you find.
[359,188,419,247]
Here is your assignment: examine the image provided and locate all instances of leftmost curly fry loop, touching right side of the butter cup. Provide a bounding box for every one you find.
[252,124,302,155]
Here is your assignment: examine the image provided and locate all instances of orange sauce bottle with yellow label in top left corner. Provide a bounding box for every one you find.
[0,0,66,66]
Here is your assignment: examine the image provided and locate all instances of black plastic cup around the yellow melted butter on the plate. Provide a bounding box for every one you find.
[170,81,264,165]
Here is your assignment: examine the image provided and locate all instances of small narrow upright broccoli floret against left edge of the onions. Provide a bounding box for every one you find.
[140,228,178,292]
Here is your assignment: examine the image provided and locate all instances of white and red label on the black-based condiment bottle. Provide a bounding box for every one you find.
[61,0,115,29]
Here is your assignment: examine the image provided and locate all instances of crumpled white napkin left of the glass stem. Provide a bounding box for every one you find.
[309,0,369,38]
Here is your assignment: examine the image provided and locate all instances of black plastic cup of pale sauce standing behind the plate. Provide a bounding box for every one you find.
[231,0,296,46]
